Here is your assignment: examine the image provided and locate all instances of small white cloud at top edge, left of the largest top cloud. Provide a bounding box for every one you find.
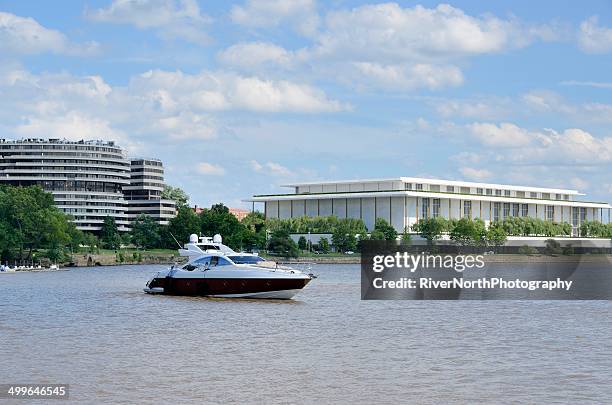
[230,0,319,35]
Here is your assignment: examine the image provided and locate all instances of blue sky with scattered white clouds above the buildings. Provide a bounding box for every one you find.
[0,0,612,207]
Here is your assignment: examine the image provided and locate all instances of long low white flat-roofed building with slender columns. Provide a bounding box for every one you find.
[248,177,611,235]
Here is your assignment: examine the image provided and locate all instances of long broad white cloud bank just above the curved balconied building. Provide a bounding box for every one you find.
[0,66,345,159]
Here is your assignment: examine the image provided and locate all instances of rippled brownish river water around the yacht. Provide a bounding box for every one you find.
[0,265,612,404]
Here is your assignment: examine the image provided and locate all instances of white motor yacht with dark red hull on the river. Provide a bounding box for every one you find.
[144,234,316,299]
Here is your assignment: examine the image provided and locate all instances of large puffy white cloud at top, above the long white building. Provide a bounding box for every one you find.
[316,3,551,61]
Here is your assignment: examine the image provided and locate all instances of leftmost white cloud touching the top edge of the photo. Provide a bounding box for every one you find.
[86,0,212,44]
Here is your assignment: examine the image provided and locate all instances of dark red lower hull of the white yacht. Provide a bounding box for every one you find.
[149,277,310,296]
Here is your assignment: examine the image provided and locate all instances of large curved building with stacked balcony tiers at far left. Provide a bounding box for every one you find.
[0,139,177,232]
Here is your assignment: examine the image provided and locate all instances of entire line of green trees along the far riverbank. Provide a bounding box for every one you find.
[0,186,612,262]
